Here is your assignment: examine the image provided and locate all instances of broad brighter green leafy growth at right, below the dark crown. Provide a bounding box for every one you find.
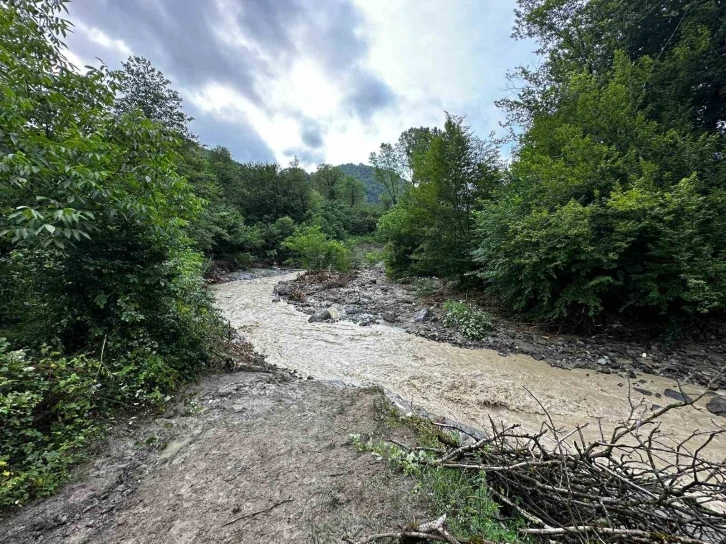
[474,60,726,326]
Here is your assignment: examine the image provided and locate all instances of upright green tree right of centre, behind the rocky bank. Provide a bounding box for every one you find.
[378,114,500,276]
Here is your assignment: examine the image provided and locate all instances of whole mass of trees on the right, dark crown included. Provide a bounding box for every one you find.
[475,0,726,322]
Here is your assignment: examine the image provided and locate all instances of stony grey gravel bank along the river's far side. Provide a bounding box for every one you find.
[277,266,726,389]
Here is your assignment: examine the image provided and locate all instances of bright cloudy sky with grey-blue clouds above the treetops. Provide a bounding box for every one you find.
[67,0,534,168]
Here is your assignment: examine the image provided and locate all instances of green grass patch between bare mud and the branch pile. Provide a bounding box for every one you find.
[350,402,528,543]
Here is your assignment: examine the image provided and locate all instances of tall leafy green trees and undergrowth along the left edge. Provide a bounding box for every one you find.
[0,0,221,506]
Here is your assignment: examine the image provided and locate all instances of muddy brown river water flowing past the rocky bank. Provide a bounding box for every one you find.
[214,274,726,456]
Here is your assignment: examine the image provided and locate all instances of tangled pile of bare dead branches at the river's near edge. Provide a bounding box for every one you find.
[346,378,726,544]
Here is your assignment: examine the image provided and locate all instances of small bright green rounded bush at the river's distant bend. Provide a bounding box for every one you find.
[283,226,352,272]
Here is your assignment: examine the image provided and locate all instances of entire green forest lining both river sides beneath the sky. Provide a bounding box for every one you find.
[0,0,726,507]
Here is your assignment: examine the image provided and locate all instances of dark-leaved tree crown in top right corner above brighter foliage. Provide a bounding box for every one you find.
[501,0,726,139]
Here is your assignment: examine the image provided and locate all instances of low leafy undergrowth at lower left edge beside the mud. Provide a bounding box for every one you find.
[0,338,100,508]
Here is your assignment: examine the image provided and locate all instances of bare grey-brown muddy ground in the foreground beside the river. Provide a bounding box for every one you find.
[0,372,425,544]
